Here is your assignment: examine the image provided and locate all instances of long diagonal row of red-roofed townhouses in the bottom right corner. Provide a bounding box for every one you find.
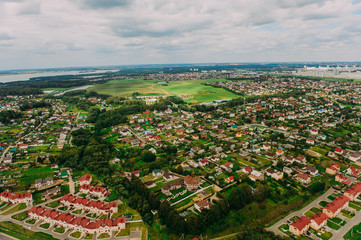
[289,182,361,236]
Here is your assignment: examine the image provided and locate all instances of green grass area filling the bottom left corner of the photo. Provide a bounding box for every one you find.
[0,222,57,240]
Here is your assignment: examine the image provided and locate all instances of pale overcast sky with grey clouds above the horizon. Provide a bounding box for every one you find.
[0,0,361,70]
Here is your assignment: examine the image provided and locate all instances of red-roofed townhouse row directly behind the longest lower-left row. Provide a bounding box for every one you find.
[60,195,118,214]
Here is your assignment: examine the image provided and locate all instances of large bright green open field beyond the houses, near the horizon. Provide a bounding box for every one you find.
[87,79,239,102]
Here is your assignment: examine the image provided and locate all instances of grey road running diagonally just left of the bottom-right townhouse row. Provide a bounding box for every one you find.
[267,188,334,236]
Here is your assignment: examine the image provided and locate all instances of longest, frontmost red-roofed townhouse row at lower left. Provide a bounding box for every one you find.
[28,206,125,234]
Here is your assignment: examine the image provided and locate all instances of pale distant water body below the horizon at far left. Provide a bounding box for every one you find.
[0,70,118,83]
